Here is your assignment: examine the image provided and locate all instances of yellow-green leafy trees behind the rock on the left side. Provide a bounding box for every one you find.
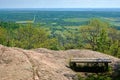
[0,23,58,50]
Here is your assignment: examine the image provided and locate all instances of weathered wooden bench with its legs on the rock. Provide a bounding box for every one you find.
[69,58,112,71]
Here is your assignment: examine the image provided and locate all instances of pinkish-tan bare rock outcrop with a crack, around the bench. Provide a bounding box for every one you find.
[0,45,119,80]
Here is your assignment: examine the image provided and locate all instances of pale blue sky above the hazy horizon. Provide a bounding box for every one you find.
[0,0,120,8]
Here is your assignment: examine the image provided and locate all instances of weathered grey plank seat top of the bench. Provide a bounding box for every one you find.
[71,58,112,63]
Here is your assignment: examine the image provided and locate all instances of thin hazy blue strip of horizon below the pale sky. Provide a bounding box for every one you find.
[0,8,120,12]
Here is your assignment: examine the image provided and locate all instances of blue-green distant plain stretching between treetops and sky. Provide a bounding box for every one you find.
[0,8,120,29]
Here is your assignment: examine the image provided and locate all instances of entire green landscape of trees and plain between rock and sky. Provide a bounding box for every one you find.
[0,9,120,58]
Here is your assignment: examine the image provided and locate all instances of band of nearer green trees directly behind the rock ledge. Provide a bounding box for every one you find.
[0,18,120,58]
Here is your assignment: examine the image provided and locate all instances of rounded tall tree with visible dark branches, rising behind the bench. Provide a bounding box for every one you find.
[80,19,108,51]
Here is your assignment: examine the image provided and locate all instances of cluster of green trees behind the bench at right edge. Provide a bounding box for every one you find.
[80,19,120,57]
